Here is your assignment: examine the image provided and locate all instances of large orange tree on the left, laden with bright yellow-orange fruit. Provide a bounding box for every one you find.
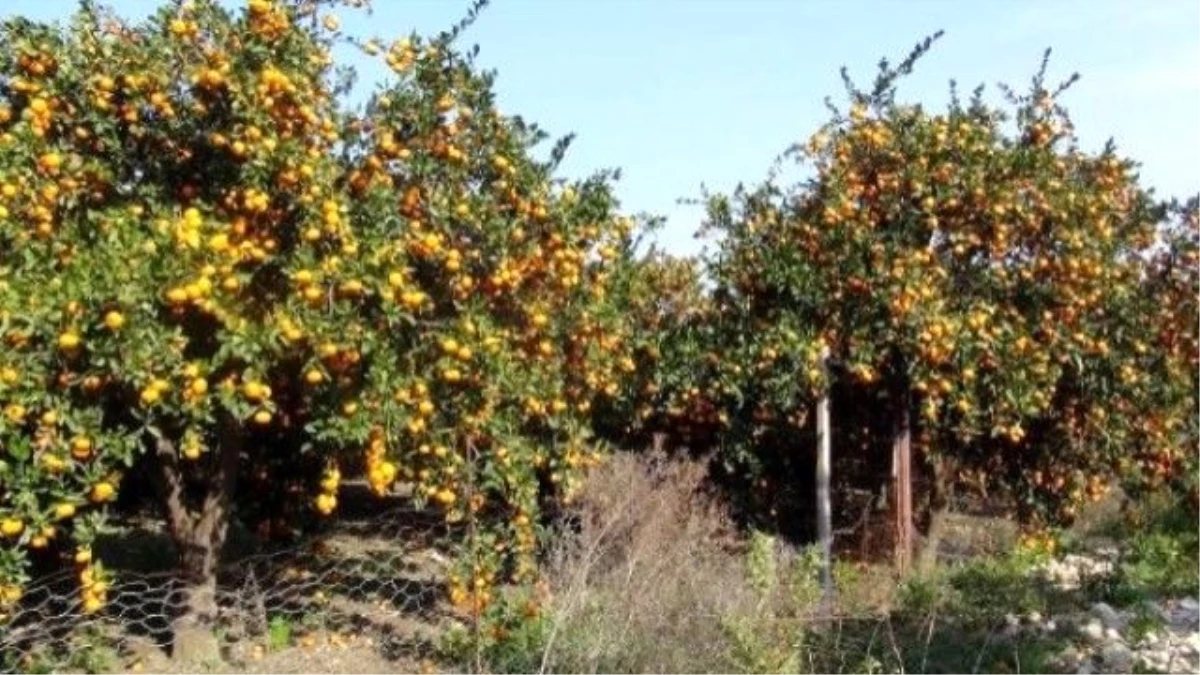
[0,0,632,626]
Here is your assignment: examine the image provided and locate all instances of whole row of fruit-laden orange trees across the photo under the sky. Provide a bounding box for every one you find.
[0,0,1200,621]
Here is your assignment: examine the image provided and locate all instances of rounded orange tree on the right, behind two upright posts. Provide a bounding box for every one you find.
[686,40,1168,547]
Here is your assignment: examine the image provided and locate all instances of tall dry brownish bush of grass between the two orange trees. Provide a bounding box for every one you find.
[525,455,825,674]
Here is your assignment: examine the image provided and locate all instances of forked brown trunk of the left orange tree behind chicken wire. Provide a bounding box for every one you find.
[156,420,241,662]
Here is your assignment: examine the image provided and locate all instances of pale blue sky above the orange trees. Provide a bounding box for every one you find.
[9,0,1200,253]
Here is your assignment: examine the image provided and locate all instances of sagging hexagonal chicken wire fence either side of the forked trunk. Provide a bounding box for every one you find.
[0,509,469,675]
